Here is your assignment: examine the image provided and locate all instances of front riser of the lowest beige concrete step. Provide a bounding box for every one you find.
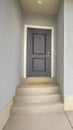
[11,105,64,114]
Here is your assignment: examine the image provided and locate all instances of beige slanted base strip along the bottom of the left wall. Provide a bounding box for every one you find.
[0,99,13,130]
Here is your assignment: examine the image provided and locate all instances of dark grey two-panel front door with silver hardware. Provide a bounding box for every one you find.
[27,28,51,77]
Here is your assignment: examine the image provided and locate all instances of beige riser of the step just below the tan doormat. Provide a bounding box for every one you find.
[16,87,60,95]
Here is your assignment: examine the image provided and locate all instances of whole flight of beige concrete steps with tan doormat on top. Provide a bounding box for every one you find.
[11,77,63,113]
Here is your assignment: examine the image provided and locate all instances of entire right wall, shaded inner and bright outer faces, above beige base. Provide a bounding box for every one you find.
[57,0,73,96]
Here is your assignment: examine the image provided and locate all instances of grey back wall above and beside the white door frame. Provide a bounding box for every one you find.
[21,14,56,77]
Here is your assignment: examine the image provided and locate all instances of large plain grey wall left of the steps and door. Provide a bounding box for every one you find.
[0,0,22,110]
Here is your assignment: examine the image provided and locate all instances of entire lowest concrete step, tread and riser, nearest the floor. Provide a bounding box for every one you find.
[11,103,64,114]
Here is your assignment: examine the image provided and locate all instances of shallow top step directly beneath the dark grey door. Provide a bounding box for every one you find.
[21,77,55,84]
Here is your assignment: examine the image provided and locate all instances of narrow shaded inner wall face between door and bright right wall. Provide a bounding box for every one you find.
[56,0,64,94]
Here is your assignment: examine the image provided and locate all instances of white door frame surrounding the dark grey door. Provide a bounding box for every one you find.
[23,25,55,78]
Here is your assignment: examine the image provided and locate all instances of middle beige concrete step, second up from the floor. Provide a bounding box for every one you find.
[14,94,61,103]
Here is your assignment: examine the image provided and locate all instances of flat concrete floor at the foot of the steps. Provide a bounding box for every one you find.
[3,112,73,130]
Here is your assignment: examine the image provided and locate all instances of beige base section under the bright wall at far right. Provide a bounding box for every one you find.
[64,96,73,111]
